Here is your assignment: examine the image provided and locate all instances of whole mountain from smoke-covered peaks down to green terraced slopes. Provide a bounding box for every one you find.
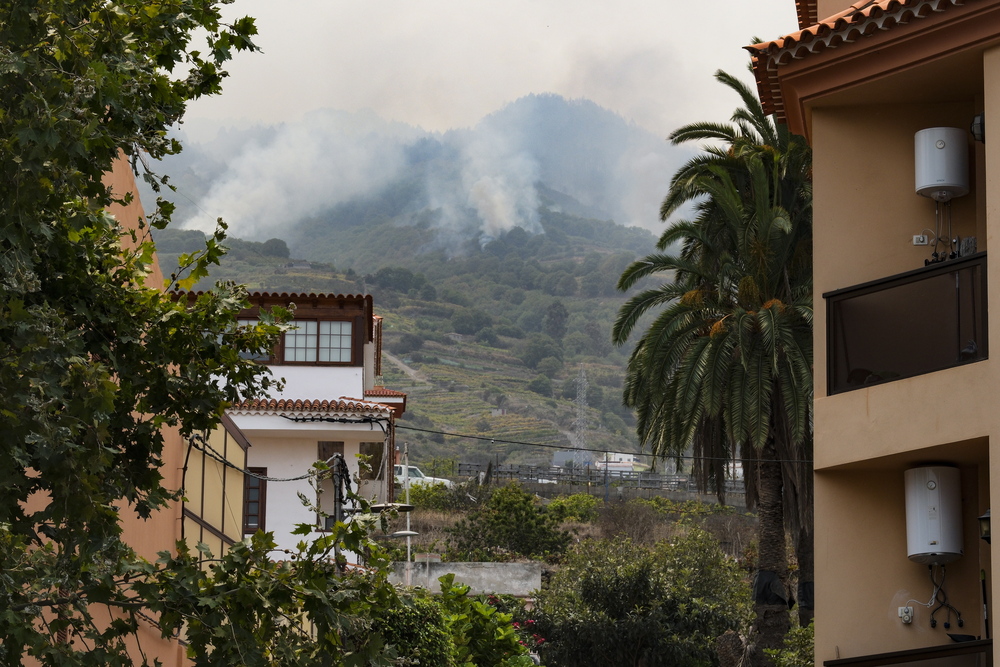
[146,95,686,464]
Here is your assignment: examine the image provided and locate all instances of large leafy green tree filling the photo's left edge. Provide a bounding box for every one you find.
[0,0,316,665]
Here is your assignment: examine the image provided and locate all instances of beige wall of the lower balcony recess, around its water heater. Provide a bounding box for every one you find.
[815,456,985,663]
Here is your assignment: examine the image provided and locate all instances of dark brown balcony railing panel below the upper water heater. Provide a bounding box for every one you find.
[823,253,989,395]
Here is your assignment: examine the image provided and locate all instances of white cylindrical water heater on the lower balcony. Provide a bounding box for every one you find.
[905,466,963,564]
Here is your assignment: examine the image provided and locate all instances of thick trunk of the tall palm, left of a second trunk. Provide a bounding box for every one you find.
[754,438,790,666]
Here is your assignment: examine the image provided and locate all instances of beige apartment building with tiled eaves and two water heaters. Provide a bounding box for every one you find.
[749,0,1000,666]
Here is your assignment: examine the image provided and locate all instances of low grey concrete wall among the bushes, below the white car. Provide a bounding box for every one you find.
[389,562,542,597]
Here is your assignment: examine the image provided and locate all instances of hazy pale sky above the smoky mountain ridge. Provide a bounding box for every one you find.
[188,0,796,136]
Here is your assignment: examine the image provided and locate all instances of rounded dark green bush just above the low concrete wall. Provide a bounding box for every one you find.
[448,483,570,561]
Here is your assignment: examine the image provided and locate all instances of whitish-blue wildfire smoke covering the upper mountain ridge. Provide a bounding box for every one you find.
[170,95,686,249]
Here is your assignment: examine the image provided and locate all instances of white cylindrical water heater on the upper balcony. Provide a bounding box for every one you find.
[913,127,969,202]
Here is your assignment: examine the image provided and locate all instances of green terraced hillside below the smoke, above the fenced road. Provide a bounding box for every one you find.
[156,210,654,465]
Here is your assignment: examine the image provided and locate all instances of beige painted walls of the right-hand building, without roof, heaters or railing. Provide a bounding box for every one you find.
[811,40,1000,664]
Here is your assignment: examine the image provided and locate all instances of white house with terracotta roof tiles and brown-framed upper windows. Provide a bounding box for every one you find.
[228,293,406,549]
